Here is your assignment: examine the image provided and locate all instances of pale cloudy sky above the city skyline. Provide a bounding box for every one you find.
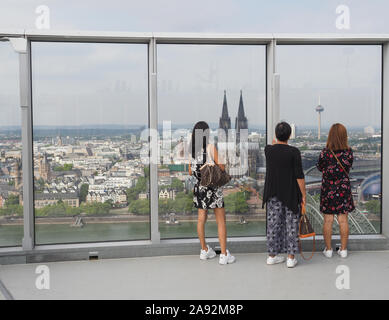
[0,0,389,127]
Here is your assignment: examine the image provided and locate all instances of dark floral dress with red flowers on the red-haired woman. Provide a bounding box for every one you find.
[317,148,355,214]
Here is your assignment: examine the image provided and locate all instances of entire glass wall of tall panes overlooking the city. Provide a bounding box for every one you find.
[0,35,382,247]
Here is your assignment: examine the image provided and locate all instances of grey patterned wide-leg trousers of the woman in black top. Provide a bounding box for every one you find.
[266,197,300,255]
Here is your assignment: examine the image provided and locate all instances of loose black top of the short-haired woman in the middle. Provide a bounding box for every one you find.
[262,144,304,214]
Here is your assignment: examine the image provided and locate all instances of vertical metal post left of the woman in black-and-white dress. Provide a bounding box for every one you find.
[149,38,161,244]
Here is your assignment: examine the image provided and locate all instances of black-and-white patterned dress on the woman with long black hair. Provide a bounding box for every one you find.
[191,155,224,210]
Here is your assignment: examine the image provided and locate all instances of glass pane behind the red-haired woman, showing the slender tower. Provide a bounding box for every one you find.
[277,45,382,234]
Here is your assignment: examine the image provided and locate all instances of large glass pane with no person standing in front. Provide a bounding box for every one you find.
[32,42,150,244]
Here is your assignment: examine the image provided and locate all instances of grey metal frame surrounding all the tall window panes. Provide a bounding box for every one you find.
[0,29,389,259]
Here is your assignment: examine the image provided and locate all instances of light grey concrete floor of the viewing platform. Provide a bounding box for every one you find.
[0,251,389,299]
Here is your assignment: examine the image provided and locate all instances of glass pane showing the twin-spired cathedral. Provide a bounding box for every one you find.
[158,44,266,238]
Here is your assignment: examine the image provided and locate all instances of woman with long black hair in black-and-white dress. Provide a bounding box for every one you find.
[189,121,235,265]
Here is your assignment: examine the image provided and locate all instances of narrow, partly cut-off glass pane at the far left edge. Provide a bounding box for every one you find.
[0,42,23,247]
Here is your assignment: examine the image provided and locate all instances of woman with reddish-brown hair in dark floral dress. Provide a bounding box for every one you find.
[317,123,355,258]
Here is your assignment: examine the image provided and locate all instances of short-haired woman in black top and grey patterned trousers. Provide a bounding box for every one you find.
[262,122,306,268]
